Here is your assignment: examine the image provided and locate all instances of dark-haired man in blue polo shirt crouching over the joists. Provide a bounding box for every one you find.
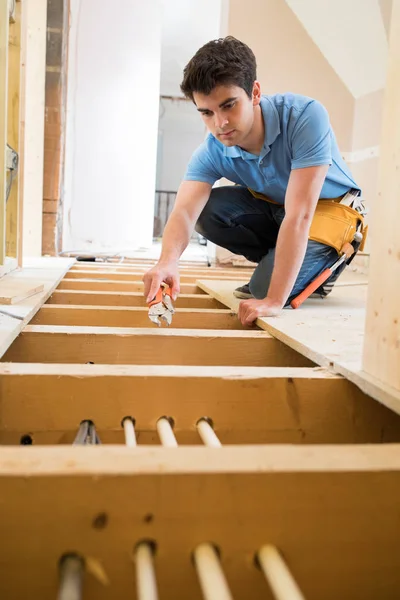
[144,36,366,325]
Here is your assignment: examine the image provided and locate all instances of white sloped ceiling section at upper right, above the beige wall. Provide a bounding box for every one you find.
[286,0,390,98]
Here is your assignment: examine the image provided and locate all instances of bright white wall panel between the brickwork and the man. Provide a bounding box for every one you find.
[63,0,161,251]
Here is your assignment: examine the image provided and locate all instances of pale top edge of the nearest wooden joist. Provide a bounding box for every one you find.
[0,444,400,480]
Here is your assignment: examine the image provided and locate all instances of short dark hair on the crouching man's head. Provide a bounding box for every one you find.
[181,35,257,100]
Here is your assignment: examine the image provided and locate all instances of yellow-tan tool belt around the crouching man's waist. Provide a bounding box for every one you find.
[248,188,368,254]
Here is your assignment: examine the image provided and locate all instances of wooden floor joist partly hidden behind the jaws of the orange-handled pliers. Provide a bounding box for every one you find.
[30,304,252,329]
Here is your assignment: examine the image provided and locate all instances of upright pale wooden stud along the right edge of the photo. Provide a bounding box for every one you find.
[363,0,400,392]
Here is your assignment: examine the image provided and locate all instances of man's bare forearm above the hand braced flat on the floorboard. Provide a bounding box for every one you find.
[268,218,310,306]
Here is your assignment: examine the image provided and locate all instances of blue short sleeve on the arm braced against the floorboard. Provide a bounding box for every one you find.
[291,100,332,169]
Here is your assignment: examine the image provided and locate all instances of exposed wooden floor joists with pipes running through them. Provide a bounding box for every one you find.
[0,259,400,600]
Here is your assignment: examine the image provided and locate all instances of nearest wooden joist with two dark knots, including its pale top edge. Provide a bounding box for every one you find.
[0,445,400,600]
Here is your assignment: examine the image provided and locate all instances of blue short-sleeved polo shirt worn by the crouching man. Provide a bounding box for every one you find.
[184,94,360,204]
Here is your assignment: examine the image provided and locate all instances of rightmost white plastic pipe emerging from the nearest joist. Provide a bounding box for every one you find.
[258,544,305,600]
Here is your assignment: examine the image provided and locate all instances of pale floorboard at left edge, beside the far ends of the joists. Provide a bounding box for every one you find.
[0,258,72,356]
